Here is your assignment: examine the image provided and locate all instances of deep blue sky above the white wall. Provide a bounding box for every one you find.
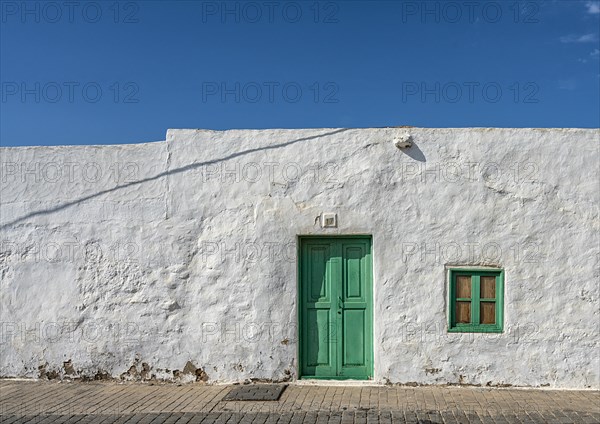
[0,0,600,146]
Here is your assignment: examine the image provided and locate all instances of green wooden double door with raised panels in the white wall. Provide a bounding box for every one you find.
[299,237,373,379]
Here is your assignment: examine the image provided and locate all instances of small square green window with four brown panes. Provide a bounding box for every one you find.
[448,269,504,333]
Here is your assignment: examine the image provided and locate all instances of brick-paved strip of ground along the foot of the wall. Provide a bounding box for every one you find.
[0,380,600,424]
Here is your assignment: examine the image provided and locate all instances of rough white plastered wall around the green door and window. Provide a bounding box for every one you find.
[0,128,600,388]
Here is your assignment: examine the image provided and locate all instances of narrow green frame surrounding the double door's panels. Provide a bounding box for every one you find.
[296,234,375,380]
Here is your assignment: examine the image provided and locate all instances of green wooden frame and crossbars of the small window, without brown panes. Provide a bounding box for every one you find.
[448,268,504,333]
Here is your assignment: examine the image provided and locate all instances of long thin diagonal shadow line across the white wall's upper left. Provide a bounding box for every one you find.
[0,128,349,230]
